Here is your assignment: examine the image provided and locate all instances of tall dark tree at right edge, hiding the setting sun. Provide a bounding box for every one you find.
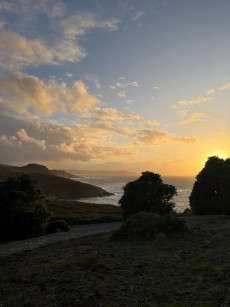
[190,156,230,215]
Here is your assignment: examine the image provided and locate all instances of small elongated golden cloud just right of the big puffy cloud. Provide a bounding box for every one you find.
[94,108,143,121]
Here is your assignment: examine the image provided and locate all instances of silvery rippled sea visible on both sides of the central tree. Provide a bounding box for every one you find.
[75,176,195,211]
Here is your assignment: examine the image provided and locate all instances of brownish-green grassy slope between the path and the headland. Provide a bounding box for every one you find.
[43,200,123,224]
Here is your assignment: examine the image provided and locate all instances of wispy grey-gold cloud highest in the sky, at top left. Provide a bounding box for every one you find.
[0,10,119,71]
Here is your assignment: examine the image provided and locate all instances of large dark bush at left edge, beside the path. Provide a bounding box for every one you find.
[0,175,49,238]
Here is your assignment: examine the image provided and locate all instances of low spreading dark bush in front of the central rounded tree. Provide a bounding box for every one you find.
[113,212,186,239]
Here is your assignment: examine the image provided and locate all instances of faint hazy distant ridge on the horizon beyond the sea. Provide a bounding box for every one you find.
[67,170,140,177]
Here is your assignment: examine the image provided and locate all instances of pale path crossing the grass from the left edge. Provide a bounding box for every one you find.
[0,222,121,257]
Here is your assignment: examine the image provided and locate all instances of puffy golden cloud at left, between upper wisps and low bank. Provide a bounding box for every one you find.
[0,73,99,116]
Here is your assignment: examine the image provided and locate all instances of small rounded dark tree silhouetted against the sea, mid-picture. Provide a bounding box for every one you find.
[119,172,176,219]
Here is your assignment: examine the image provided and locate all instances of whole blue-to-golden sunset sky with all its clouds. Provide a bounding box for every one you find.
[0,0,230,176]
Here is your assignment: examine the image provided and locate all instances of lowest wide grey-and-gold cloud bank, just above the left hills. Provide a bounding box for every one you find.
[0,115,134,163]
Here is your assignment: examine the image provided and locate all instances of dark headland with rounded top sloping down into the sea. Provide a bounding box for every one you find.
[0,164,111,199]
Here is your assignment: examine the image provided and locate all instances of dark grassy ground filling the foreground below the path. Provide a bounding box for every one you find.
[0,216,230,307]
